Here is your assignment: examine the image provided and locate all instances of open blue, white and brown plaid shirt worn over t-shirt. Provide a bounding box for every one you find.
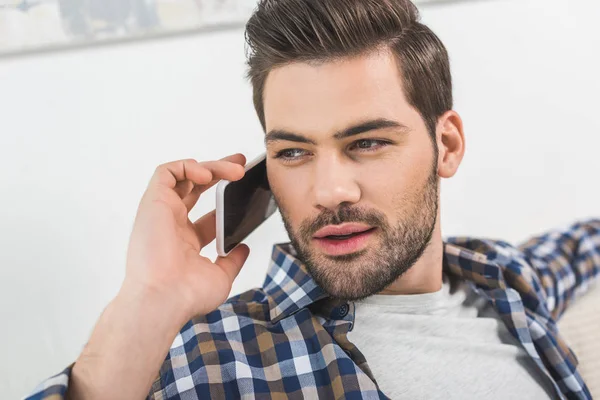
[29,220,600,400]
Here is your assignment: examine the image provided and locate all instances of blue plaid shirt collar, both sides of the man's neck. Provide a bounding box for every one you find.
[263,239,506,322]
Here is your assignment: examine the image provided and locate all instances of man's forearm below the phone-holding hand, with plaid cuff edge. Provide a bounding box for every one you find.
[28,288,186,400]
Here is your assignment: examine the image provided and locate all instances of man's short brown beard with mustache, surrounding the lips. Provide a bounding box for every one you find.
[280,164,438,301]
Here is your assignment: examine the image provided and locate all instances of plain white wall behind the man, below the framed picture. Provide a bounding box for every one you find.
[0,0,600,398]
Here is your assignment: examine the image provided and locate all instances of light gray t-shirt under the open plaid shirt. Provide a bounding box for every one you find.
[348,283,556,400]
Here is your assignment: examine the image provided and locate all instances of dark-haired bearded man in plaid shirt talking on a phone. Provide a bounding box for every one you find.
[31,0,600,399]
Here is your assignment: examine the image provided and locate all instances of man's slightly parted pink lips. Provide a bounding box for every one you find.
[313,223,377,256]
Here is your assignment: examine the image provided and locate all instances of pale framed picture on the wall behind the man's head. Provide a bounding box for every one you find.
[0,0,468,55]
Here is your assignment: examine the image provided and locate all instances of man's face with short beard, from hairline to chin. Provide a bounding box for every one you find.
[264,51,438,300]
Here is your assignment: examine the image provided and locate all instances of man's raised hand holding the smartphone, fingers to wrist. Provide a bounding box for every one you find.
[123,154,249,319]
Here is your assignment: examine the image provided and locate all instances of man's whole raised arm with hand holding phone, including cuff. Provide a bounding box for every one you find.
[30,156,248,400]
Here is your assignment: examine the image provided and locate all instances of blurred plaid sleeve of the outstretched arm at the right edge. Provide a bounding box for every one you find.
[519,219,600,320]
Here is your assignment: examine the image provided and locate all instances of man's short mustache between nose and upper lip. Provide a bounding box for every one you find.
[299,207,387,238]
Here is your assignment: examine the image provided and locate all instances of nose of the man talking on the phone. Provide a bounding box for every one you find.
[313,157,361,210]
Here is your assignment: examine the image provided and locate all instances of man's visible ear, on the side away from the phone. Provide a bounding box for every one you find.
[436,111,465,178]
